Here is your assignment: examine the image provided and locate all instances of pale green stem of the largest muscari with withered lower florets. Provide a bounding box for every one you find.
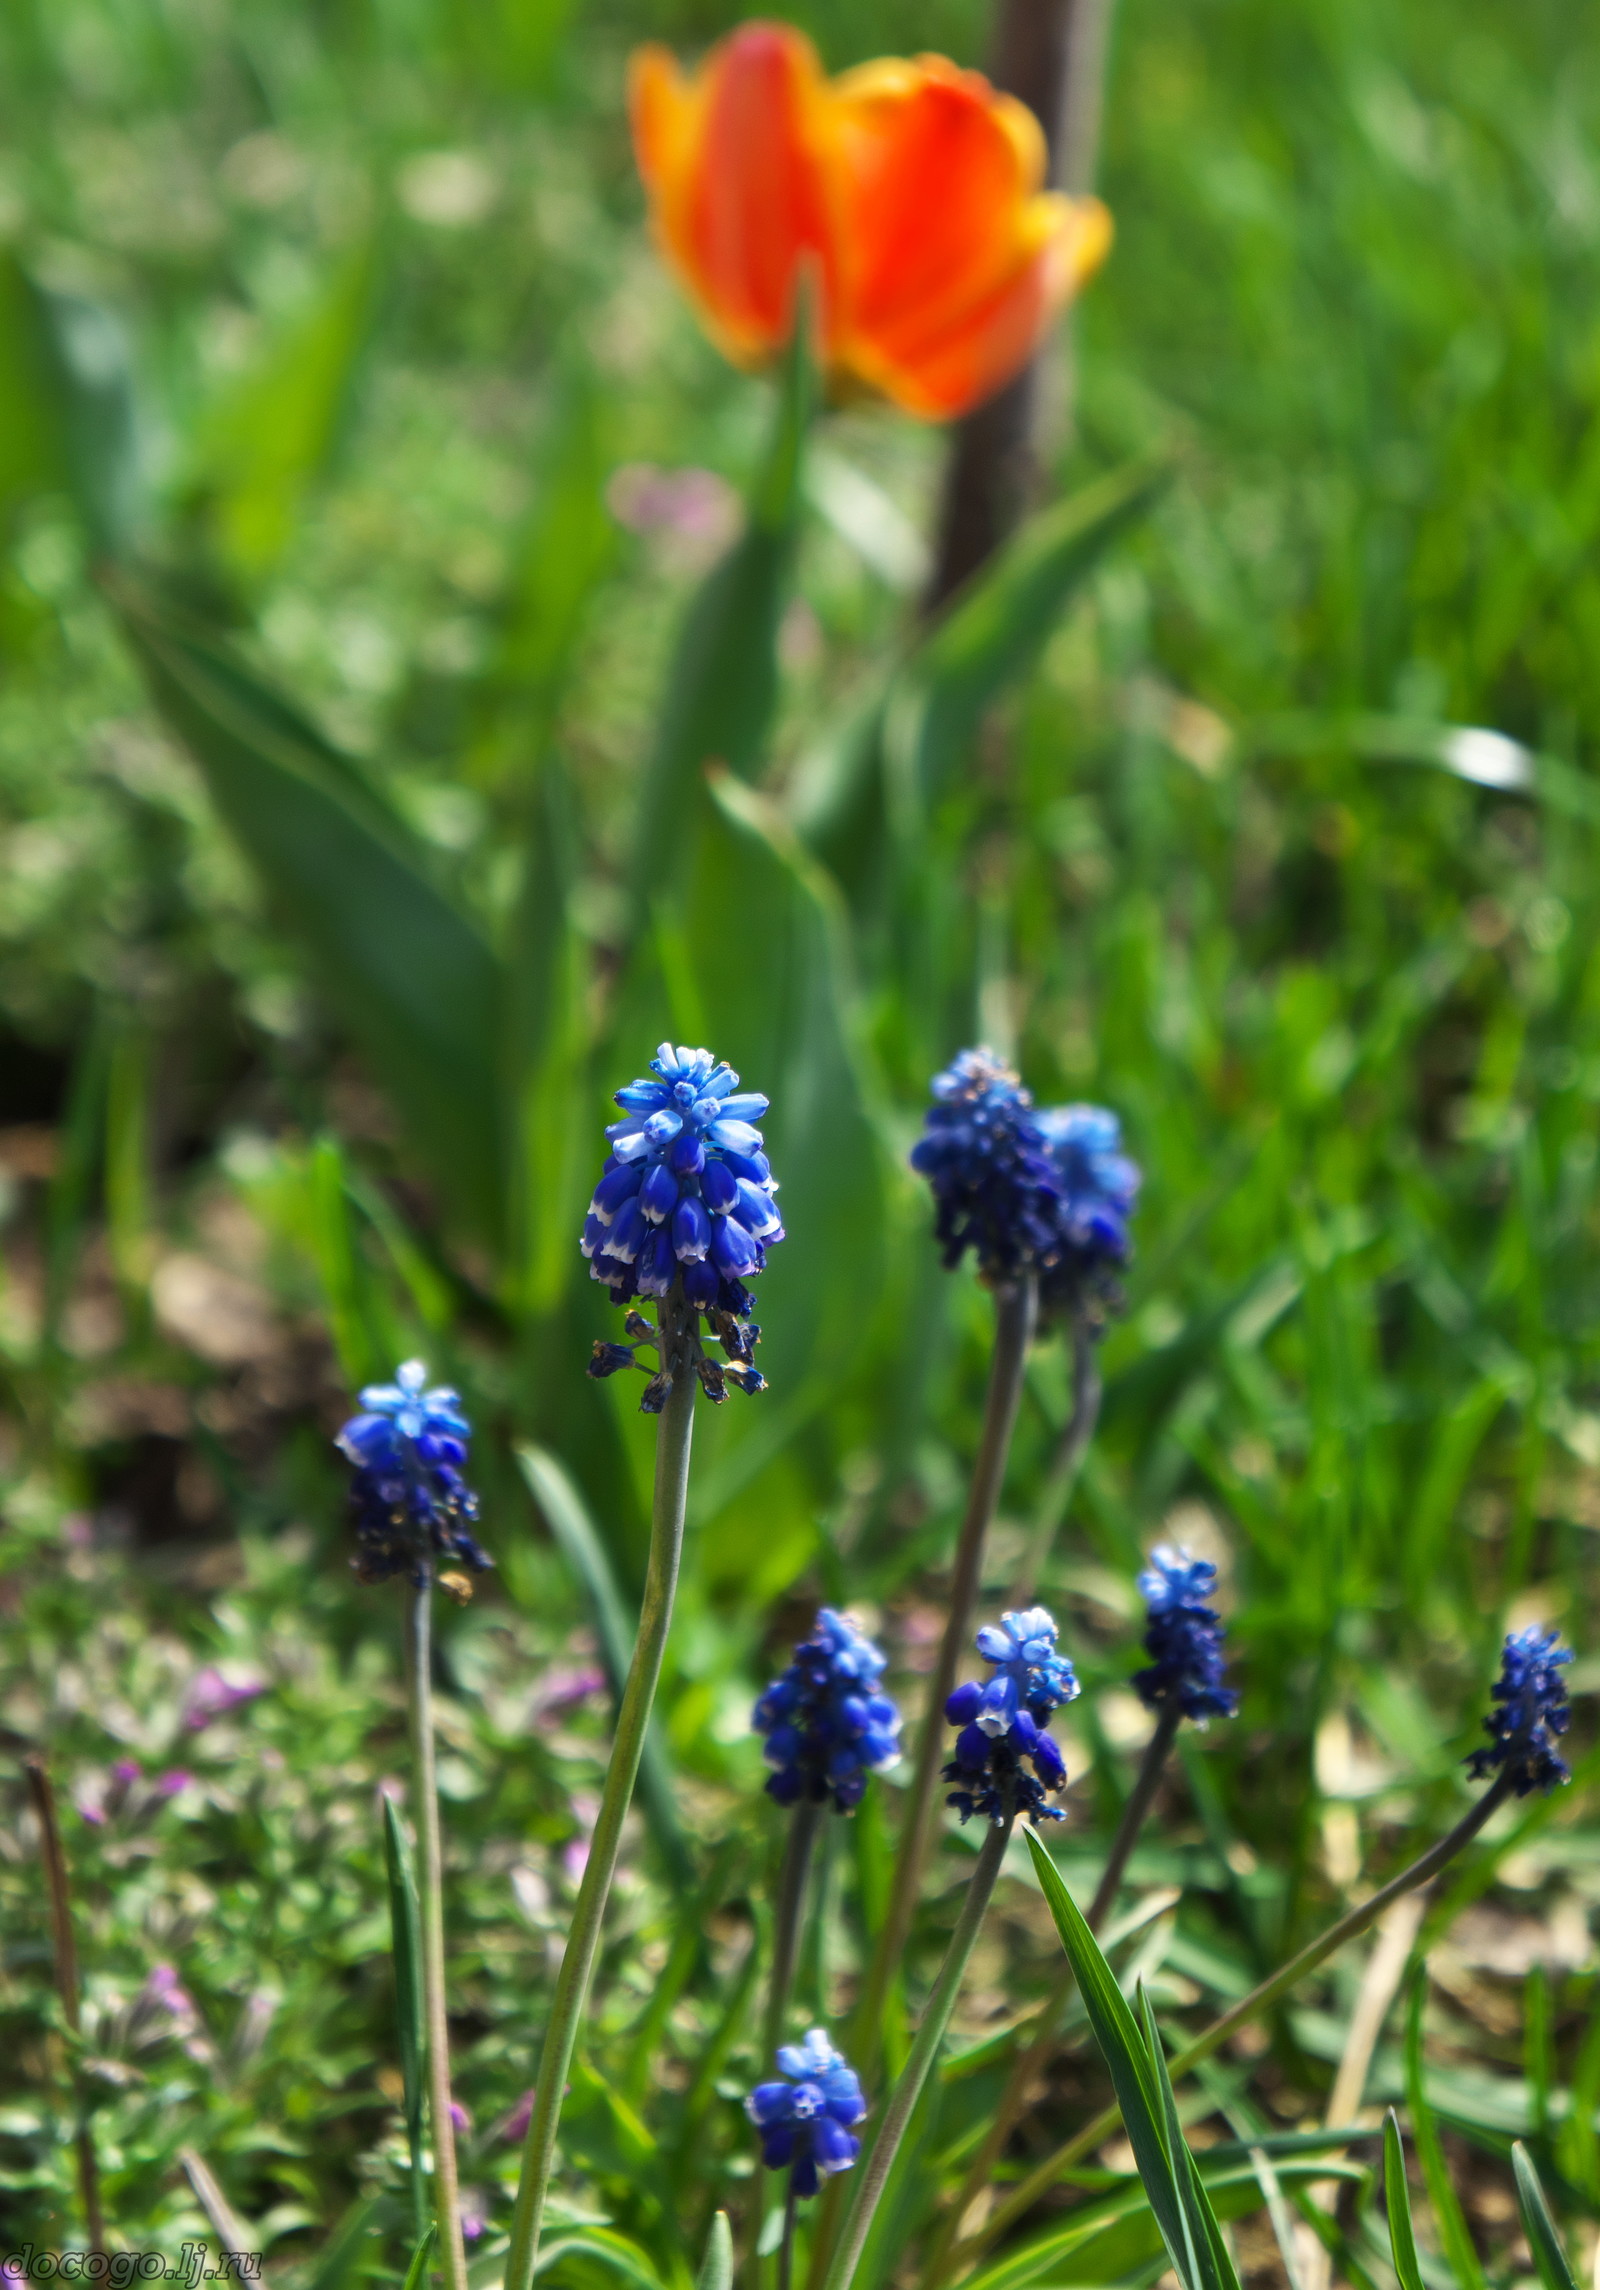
[504,1296,694,2290]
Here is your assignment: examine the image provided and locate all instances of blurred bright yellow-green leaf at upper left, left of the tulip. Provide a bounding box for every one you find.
[190,243,375,582]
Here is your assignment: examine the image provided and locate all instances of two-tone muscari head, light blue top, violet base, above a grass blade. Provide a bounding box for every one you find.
[943,1605,1078,1827]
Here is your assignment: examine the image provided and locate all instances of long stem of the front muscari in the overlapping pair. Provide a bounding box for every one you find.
[851,1278,1039,2088]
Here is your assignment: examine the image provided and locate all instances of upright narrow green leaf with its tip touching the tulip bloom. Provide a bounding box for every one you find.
[632,325,813,930]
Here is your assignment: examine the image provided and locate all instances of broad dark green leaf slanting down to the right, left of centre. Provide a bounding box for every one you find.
[105,575,506,1239]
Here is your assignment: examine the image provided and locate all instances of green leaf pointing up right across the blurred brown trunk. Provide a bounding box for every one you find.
[886,463,1167,818]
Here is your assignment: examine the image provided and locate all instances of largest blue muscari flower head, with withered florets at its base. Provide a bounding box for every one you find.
[579,1042,783,1415]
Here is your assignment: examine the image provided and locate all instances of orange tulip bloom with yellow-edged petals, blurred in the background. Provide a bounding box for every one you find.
[629,23,1110,421]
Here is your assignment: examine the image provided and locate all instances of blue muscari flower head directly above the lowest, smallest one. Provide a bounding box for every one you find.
[751,1605,900,1814]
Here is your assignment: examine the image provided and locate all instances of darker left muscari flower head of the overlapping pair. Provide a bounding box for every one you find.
[911,1049,1062,1282]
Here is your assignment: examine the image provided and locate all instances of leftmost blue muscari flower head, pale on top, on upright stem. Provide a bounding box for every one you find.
[336,1360,492,1589]
